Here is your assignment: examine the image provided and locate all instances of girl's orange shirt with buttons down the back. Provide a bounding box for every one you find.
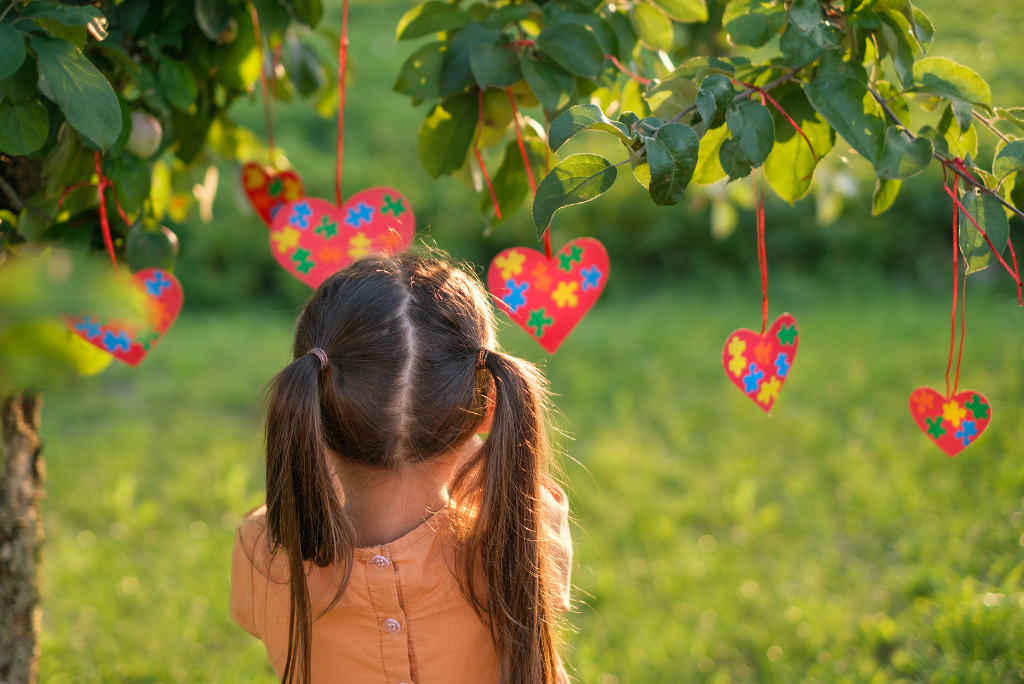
[230,483,572,684]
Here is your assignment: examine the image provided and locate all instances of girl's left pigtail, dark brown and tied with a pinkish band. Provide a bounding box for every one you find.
[265,353,355,684]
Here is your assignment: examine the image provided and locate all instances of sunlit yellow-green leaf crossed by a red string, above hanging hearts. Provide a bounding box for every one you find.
[765,84,836,204]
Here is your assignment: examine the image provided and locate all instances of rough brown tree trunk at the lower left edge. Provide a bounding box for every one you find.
[0,390,46,684]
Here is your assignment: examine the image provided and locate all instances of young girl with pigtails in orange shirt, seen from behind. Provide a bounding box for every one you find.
[230,253,571,684]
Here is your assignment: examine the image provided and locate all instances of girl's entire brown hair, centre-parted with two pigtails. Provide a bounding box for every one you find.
[256,252,558,684]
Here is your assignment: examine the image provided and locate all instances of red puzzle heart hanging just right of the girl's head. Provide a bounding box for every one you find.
[487,238,610,354]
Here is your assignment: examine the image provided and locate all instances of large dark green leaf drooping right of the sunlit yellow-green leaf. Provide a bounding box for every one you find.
[804,51,886,166]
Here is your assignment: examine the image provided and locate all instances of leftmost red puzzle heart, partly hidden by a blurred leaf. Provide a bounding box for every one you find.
[65,268,184,366]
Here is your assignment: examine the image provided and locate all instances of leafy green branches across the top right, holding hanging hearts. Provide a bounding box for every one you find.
[385,0,1024,278]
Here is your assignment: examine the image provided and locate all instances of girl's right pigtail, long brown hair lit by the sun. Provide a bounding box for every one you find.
[454,351,559,684]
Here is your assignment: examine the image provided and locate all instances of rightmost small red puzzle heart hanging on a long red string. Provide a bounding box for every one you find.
[909,387,992,457]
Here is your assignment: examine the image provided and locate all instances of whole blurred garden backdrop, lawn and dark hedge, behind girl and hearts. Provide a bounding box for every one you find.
[41,0,1024,684]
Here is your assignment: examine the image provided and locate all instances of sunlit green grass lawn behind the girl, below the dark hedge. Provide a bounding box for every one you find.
[36,279,1024,684]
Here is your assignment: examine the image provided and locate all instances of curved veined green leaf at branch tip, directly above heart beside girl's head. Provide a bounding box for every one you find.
[534,154,616,233]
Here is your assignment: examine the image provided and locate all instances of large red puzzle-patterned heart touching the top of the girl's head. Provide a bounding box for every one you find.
[270,187,416,288]
